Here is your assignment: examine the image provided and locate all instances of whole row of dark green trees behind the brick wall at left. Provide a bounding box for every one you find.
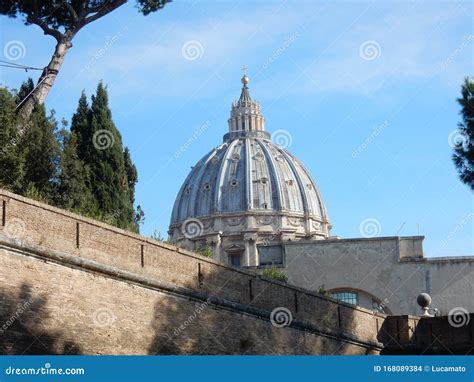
[0,81,145,232]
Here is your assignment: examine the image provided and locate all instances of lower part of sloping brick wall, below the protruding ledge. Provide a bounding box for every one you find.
[0,248,380,354]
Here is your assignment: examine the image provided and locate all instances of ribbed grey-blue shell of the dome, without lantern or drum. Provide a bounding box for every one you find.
[171,136,328,225]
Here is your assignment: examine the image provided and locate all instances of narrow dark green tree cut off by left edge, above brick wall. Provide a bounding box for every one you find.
[0,88,24,192]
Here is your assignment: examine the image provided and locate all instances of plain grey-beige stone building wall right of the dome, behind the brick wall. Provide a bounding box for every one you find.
[266,236,474,315]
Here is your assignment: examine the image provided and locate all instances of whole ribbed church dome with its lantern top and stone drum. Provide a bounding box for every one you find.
[169,76,331,266]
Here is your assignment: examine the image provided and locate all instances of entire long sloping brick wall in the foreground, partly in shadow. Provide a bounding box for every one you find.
[0,191,385,354]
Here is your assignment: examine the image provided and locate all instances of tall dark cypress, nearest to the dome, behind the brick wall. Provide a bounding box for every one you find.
[71,83,142,231]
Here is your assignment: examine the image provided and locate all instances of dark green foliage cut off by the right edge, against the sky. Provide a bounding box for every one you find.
[451,78,474,190]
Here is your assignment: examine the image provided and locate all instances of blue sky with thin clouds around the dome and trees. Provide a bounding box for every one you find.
[0,1,474,256]
